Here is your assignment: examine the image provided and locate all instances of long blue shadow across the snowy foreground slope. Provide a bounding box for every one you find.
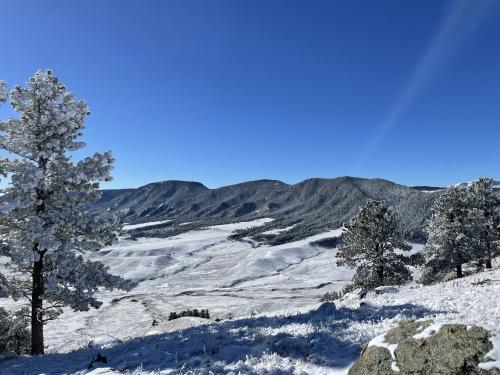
[0,303,445,375]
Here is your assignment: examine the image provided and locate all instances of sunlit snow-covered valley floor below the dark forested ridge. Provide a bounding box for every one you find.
[0,219,352,352]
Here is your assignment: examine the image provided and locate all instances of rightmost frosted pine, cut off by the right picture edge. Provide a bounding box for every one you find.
[467,177,500,268]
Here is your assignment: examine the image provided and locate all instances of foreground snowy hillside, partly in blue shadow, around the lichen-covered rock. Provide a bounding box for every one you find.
[0,270,500,375]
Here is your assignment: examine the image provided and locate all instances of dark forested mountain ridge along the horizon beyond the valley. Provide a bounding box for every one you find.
[92,177,439,244]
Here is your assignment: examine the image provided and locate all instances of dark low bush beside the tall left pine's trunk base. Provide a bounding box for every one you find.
[0,307,31,355]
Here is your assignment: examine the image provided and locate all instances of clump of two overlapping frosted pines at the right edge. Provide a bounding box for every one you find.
[422,177,500,283]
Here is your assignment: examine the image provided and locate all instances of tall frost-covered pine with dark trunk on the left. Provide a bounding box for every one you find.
[0,70,131,355]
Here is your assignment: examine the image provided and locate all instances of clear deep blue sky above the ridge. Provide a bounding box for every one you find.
[0,0,500,188]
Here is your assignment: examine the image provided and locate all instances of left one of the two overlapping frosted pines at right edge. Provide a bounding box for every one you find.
[422,186,473,283]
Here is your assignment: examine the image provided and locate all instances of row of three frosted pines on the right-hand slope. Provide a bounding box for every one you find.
[337,177,500,289]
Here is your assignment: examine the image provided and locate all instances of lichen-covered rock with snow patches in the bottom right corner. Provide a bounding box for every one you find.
[349,320,500,375]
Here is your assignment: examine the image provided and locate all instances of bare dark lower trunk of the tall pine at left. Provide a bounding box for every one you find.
[31,245,44,355]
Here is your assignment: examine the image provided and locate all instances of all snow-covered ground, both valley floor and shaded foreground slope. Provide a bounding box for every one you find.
[0,219,500,375]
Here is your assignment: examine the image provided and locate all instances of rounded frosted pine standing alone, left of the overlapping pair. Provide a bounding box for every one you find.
[337,201,411,289]
